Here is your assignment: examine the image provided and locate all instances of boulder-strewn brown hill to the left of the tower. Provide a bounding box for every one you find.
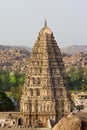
[0,45,30,72]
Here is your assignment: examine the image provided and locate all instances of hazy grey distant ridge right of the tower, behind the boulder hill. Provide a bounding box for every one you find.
[61,45,87,54]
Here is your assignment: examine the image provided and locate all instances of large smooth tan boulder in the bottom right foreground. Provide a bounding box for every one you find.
[52,115,87,130]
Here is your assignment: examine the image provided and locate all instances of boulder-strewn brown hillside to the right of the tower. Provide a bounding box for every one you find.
[62,52,87,71]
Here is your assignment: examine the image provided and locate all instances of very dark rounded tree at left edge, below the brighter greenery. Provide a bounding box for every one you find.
[0,92,15,111]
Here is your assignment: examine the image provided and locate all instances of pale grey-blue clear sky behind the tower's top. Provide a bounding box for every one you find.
[0,0,87,48]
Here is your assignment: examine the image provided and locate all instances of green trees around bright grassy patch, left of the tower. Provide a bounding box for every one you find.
[0,69,25,91]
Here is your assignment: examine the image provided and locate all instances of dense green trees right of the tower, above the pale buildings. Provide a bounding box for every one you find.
[67,68,87,91]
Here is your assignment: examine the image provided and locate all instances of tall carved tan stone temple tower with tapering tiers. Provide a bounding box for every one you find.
[20,21,70,127]
